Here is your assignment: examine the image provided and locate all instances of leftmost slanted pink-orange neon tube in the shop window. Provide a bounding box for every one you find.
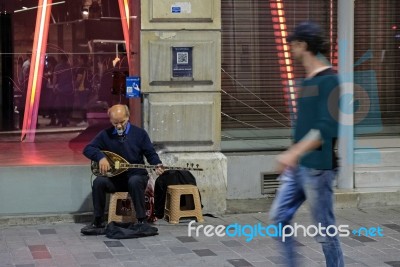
[21,0,52,142]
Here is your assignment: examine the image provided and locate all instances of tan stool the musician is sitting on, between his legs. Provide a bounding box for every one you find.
[108,192,136,223]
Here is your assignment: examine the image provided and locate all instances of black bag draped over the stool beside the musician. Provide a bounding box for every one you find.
[154,170,203,219]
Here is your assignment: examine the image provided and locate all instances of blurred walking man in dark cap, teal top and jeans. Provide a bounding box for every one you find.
[270,22,344,267]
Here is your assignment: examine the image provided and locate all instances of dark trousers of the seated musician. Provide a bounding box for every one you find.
[92,175,149,220]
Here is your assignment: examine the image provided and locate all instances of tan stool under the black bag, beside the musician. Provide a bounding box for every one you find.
[164,184,204,224]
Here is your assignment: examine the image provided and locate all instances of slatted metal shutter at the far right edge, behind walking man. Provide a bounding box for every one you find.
[354,0,400,134]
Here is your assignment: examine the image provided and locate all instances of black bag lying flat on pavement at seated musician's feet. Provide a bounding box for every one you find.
[105,222,158,239]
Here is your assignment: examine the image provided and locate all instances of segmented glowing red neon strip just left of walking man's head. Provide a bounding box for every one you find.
[270,0,297,113]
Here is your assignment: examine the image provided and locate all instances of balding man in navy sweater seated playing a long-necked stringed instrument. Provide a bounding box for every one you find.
[82,104,164,232]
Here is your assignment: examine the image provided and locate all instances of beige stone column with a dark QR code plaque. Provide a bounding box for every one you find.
[140,0,227,213]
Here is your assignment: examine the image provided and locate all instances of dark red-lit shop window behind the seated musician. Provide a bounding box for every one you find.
[0,0,129,165]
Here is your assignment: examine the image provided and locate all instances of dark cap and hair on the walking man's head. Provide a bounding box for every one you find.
[286,21,328,55]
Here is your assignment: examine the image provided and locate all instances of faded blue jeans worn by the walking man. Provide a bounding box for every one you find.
[270,166,344,267]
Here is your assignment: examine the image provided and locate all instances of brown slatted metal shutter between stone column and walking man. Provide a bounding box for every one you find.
[221,0,337,144]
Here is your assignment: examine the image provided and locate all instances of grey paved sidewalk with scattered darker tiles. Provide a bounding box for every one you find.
[0,207,400,267]
